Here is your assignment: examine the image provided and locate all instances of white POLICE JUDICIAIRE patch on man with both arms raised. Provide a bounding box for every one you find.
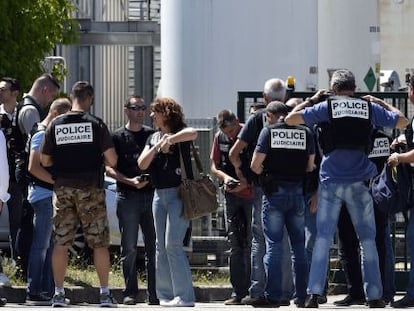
[331,98,369,120]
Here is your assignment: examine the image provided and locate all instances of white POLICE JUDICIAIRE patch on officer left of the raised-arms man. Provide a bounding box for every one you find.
[270,129,306,150]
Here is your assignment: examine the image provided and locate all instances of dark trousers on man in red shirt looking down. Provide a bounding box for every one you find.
[224,192,252,298]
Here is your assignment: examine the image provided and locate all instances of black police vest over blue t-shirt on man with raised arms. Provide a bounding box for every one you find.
[319,96,372,154]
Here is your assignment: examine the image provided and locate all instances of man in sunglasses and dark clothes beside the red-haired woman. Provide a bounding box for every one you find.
[106,95,159,305]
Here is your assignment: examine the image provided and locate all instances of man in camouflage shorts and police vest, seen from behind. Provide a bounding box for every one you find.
[40,81,117,307]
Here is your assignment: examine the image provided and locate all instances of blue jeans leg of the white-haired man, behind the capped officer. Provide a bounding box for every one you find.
[249,187,266,298]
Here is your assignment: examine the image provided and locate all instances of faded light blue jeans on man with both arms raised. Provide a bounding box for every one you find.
[308,181,382,300]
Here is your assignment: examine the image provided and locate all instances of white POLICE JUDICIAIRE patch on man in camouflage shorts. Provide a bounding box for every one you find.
[55,122,93,145]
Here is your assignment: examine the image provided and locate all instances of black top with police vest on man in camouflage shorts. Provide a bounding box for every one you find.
[41,111,114,189]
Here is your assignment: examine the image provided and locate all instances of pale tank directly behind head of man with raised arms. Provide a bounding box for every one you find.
[318,0,380,91]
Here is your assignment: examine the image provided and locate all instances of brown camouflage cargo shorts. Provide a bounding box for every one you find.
[53,187,109,248]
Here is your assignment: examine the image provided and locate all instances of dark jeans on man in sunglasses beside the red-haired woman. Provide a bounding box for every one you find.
[116,191,157,300]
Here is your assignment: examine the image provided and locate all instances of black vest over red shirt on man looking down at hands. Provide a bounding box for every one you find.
[218,131,251,181]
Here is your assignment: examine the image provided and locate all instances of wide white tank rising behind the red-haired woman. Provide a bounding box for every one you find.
[159,0,317,118]
